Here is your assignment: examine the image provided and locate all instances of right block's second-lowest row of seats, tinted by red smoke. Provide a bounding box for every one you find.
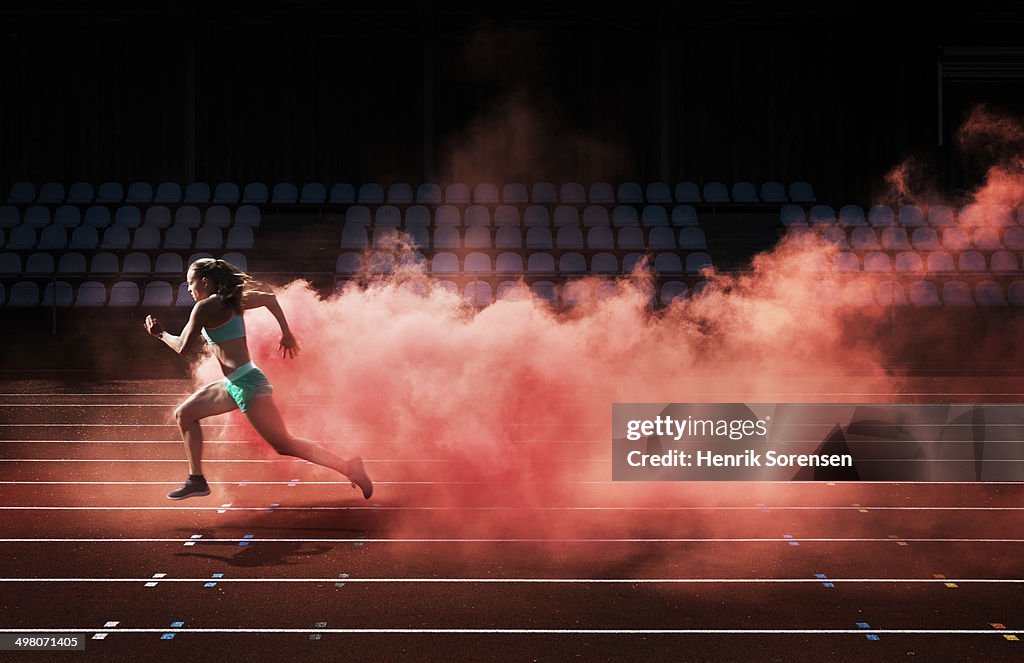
[806,251,1021,274]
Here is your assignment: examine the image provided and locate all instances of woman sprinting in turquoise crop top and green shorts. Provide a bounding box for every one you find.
[145,258,374,499]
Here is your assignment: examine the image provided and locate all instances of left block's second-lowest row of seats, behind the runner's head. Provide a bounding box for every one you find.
[0,252,249,276]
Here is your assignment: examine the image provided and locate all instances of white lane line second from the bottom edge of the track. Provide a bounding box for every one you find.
[0,576,1024,585]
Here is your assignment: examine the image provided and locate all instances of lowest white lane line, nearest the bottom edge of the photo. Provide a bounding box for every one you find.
[0,627,1024,636]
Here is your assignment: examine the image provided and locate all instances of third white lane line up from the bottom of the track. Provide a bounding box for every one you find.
[0,537,1024,544]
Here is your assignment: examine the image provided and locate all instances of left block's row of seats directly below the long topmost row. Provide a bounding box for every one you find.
[0,205,262,229]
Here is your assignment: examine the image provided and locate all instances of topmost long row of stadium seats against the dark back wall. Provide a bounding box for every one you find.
[7,181,814,205]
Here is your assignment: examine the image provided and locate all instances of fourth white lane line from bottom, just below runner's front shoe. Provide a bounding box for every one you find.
[6,506,1024,513]
